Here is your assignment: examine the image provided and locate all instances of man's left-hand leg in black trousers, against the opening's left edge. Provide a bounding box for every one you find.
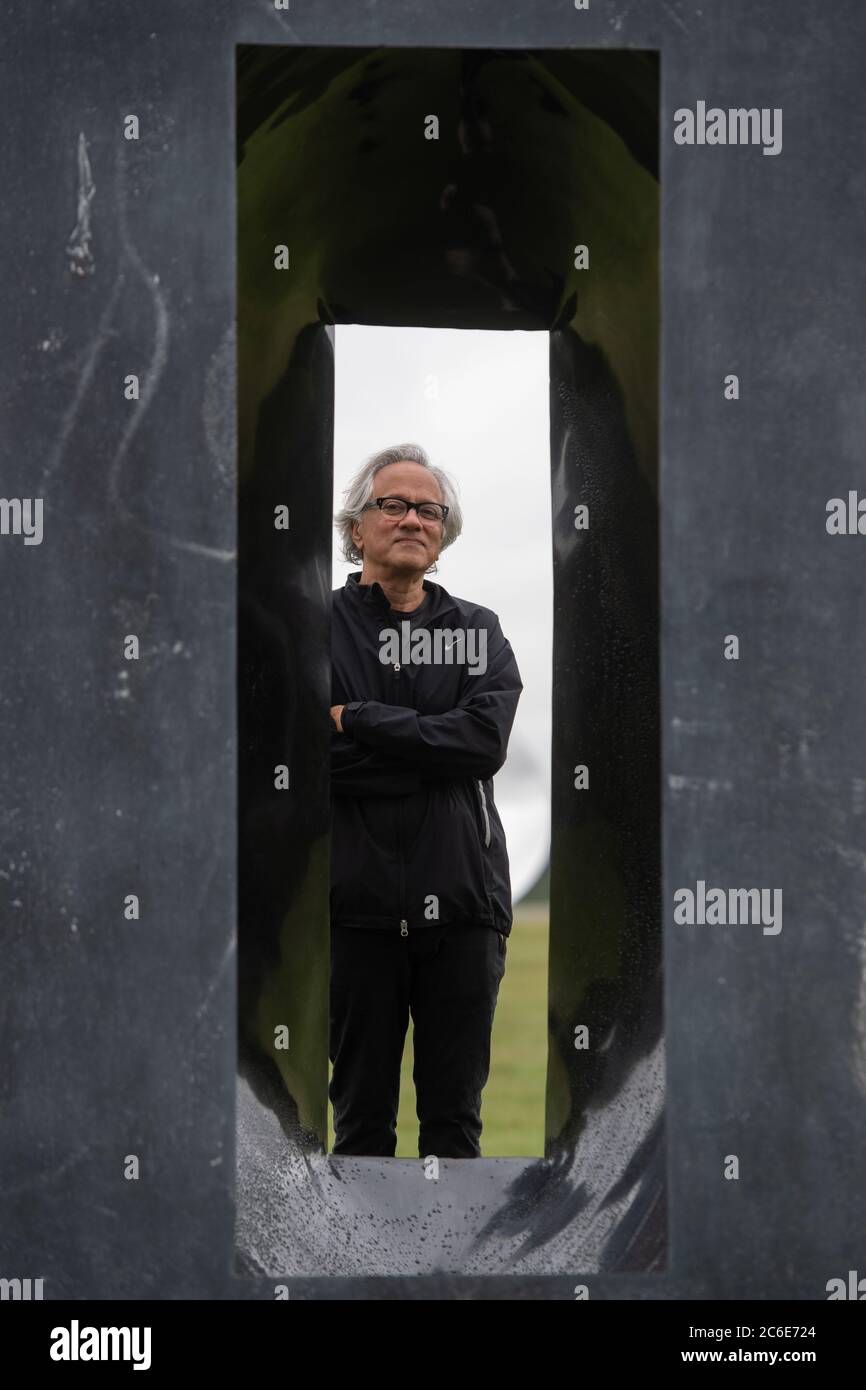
[328,927,409,1158]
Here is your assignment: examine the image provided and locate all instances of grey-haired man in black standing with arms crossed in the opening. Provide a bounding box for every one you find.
[328,445,523,1158]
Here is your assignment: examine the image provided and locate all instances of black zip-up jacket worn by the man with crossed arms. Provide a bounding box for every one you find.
[331,570,523,937]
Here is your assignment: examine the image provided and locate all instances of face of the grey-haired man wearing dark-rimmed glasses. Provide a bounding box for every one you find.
[352,460,445,574]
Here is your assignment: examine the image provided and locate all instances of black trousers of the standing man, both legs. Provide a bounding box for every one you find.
[328,923,507,1158]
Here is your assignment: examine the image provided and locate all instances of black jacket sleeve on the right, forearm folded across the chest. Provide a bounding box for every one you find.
[342,620,523,781]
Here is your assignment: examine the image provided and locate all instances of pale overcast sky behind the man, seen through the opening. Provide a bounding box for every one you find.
[334,324,553,902]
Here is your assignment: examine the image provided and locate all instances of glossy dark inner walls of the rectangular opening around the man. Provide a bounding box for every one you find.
[238,47,666,1275]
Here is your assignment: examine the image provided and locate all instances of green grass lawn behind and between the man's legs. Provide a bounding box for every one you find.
[328,902,549,1158]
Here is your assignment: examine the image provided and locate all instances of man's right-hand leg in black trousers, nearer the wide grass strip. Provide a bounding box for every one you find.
[410,923,506,1158]
